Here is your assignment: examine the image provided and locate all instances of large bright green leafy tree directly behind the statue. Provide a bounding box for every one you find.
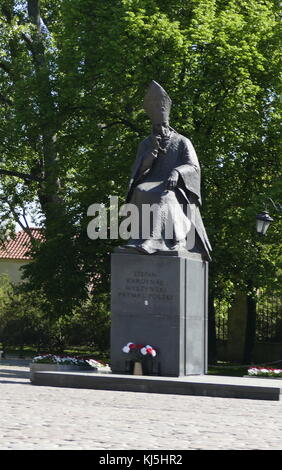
[62,0,281,360]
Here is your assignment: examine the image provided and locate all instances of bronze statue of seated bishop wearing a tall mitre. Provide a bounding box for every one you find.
[124,81,211,260]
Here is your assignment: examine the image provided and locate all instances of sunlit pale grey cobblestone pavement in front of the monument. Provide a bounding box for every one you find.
[0,360,282,450]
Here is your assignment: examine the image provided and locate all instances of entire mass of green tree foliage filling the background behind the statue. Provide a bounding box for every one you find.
[0,0,282,330]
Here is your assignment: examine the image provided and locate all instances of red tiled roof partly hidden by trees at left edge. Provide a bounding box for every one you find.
[0,228,42,259]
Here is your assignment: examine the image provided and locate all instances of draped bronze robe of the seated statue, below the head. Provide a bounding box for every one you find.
[126,130,211,259]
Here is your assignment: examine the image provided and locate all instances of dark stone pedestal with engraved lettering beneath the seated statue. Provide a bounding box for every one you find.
[111,252,208,377]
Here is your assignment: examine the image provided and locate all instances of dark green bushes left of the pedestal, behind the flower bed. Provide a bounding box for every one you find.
[0,276,110,352]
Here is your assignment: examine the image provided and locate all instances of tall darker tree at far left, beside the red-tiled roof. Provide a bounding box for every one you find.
[0,0,90,316]
